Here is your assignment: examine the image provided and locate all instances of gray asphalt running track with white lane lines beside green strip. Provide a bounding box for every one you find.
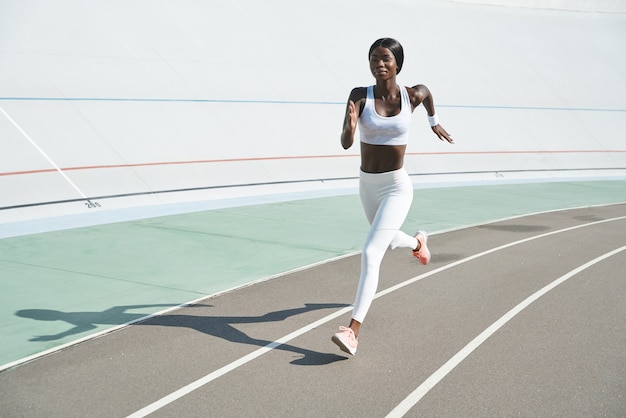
[0,205,626,417]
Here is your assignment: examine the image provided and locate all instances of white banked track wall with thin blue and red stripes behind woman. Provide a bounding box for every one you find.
[0,0,626,222]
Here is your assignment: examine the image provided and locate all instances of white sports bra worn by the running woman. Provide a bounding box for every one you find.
[359,86,412,145]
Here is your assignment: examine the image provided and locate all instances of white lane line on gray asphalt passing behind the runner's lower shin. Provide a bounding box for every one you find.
[128,216,626,418]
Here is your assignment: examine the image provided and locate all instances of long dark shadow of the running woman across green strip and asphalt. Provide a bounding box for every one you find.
[15,303,349,366]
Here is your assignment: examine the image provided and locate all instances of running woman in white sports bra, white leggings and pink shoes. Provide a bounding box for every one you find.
[332,38,454,355]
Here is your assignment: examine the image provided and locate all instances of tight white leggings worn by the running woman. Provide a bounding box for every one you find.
[352,168,417,323]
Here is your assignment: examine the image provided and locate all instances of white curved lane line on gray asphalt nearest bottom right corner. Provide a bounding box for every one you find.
[387,245,626,418]
